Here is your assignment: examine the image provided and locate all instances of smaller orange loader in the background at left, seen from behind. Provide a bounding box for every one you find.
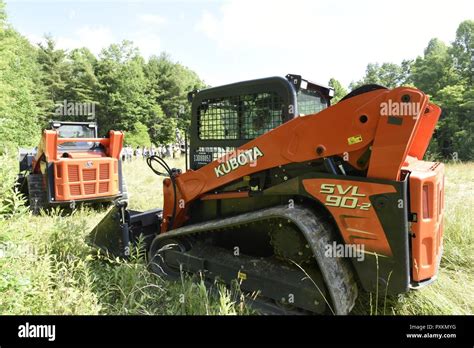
[18,121,128,213]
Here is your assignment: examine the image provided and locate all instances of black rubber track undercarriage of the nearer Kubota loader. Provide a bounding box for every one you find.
[150,206,357,314]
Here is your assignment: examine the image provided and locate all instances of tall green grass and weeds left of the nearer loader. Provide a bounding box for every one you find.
[0,155,250,315]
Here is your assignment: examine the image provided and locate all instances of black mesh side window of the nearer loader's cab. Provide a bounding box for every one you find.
[198,93,285,142]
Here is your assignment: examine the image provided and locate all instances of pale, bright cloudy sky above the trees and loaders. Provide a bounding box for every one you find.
[6,0,474,86]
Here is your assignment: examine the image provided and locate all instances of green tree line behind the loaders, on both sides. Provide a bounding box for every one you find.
[0,0,474,160]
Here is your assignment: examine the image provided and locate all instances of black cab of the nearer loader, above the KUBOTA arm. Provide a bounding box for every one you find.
[188,74,334,170]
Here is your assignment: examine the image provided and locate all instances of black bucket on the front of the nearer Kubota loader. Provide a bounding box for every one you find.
[86,202,162,258]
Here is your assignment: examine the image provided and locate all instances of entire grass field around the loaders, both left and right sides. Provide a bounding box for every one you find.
[0,156,474,315]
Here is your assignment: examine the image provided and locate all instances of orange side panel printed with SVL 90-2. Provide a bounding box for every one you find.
[303,179,396,256]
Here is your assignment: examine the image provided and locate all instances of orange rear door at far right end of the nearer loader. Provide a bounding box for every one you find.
[404,160,444,281]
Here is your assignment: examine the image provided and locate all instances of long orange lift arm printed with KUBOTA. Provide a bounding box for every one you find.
[161,87,440,232]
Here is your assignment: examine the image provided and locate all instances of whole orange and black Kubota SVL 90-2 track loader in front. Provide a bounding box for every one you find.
[90,75,444,314]
